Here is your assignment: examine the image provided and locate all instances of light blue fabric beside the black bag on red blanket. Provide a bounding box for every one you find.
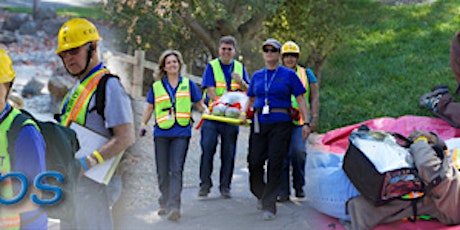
[305,152,359,221]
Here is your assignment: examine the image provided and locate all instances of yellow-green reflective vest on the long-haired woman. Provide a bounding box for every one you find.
[153,77,192,129]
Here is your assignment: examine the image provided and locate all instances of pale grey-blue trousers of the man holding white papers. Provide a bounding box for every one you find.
[61,175,123,230]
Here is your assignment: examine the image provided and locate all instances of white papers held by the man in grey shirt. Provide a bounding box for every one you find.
[70,122,123,185]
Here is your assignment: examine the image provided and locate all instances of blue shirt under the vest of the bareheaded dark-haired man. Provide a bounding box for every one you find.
[201,59,249,104]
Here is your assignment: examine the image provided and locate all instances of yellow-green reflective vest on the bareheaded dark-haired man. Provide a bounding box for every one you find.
[205,58,243,102]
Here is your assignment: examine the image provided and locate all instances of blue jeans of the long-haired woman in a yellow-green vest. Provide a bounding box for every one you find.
[154,137,190,210]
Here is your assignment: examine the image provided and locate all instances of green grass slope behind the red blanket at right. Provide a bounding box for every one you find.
[320,0,460,133]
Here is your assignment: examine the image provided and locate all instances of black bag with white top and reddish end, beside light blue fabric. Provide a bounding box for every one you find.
[342,125,425,206]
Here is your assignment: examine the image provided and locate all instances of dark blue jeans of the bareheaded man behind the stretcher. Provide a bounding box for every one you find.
[200,120,239,191]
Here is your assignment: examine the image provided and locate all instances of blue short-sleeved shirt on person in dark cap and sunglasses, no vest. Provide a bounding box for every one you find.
[247,65,306,124]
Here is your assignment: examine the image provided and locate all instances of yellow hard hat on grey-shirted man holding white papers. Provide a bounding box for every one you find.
[56,18,102,54]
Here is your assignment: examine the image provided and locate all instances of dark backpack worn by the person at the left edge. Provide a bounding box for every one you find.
[7,110,81,220]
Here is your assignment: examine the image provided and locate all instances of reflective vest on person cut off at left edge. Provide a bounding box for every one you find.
[0,108,39,230]
